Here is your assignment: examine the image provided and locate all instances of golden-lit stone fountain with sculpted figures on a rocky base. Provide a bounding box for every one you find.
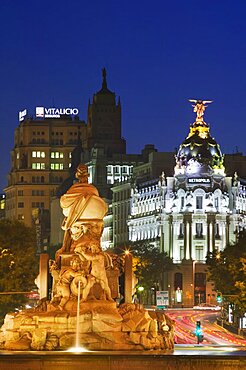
[0,164,174,351]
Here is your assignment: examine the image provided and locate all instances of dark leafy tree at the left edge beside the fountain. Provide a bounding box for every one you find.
[0,219,38,318]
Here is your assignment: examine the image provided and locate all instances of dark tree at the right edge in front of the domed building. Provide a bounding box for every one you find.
[206,231,246,315]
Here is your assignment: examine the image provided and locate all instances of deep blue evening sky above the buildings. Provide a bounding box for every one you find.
[0,0,246,190]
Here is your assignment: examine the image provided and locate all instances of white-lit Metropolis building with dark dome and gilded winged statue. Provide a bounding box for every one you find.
[128,100,246,306]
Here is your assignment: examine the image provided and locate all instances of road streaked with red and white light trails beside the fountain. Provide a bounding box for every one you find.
[165,309,246,351]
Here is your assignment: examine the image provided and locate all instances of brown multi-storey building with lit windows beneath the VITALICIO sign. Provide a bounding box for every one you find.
[5,116,86,230]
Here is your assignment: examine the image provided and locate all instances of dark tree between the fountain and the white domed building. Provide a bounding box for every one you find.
[130,241,173,289]
